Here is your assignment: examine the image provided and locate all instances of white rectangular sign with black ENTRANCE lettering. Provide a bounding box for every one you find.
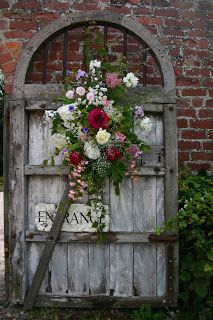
[35,203,109,232]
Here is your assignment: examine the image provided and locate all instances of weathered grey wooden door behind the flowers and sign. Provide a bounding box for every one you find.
[5,11,178,308]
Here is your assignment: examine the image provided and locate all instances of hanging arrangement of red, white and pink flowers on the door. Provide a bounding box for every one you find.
[44,60,152,232]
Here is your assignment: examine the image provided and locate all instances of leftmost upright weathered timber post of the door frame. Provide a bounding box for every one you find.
[8,100,27,303]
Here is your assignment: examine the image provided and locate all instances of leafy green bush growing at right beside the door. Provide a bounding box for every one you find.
[157,169,213,319]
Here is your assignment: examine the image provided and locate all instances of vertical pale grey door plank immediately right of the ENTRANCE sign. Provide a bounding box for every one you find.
[110,179,133,296]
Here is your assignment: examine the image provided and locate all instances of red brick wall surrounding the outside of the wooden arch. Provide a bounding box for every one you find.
[0,0,213,172]
